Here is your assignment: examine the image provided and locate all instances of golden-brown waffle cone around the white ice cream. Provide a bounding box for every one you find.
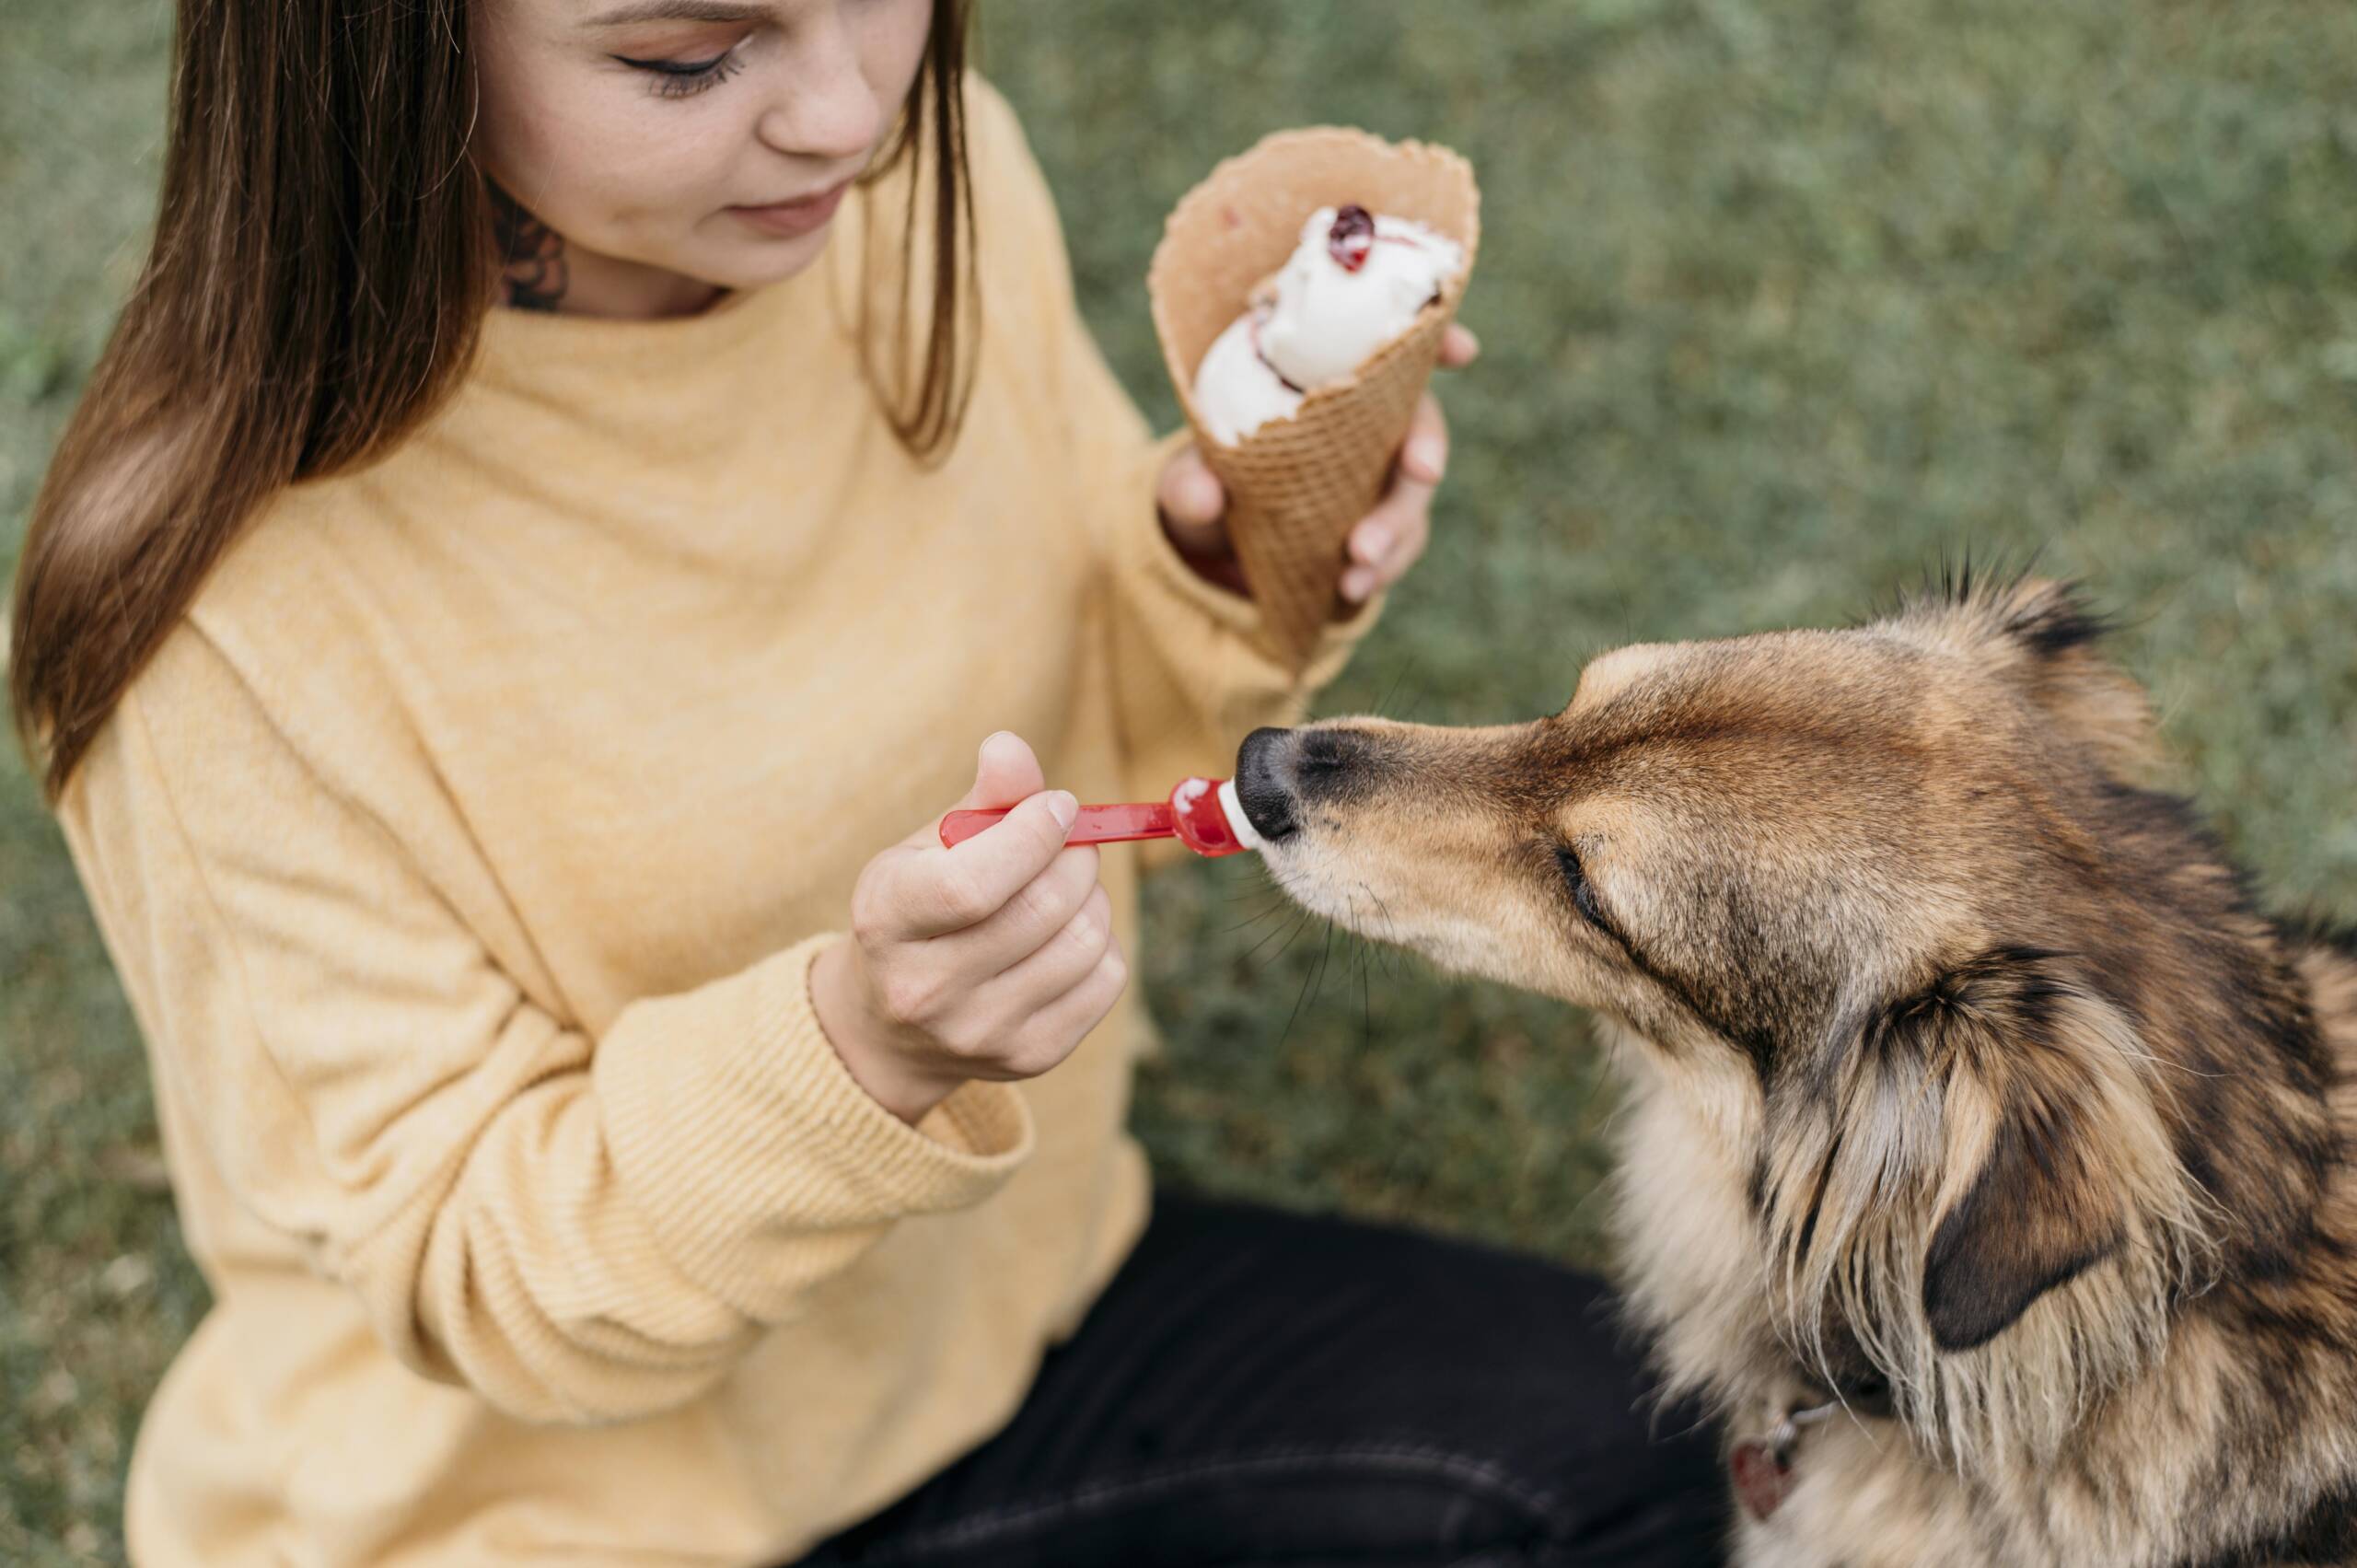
[1145,127,1480,663]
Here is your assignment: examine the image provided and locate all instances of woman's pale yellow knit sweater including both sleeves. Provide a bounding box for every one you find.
[62,87,1374,1568]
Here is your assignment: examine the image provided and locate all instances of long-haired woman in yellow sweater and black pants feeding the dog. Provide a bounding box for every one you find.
[12,0,1716,1568]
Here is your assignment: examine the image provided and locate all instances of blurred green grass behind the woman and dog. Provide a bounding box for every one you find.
[0,0,2357,1565]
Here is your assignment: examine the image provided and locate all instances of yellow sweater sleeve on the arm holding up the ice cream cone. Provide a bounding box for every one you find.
[978,92,1384,830]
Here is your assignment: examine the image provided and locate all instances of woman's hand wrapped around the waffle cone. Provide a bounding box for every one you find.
[1155,323,1480,604]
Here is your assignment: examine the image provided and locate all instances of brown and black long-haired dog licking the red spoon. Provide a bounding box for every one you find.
[1237,571,2357,1568]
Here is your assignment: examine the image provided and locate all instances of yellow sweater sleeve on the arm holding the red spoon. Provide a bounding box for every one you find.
[64,627,1032,1422]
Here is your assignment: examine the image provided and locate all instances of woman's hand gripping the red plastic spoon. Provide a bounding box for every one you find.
[811,731,1129,1122]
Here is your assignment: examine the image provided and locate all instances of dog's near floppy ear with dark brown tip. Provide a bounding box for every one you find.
[1888,947,2150,1351]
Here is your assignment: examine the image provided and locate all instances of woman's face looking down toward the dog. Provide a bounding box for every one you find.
[471,0,934,316]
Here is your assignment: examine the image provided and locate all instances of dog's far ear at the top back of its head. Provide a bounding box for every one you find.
[1888,566,2159,783]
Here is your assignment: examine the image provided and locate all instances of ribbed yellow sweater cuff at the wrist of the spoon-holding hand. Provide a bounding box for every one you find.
[592,934,1032,1323]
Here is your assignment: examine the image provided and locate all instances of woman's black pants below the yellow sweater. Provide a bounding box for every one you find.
[804,1193,1727,1568]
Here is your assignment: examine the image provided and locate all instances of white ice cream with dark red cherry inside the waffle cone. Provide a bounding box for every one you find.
[1195,205,1464,446]
